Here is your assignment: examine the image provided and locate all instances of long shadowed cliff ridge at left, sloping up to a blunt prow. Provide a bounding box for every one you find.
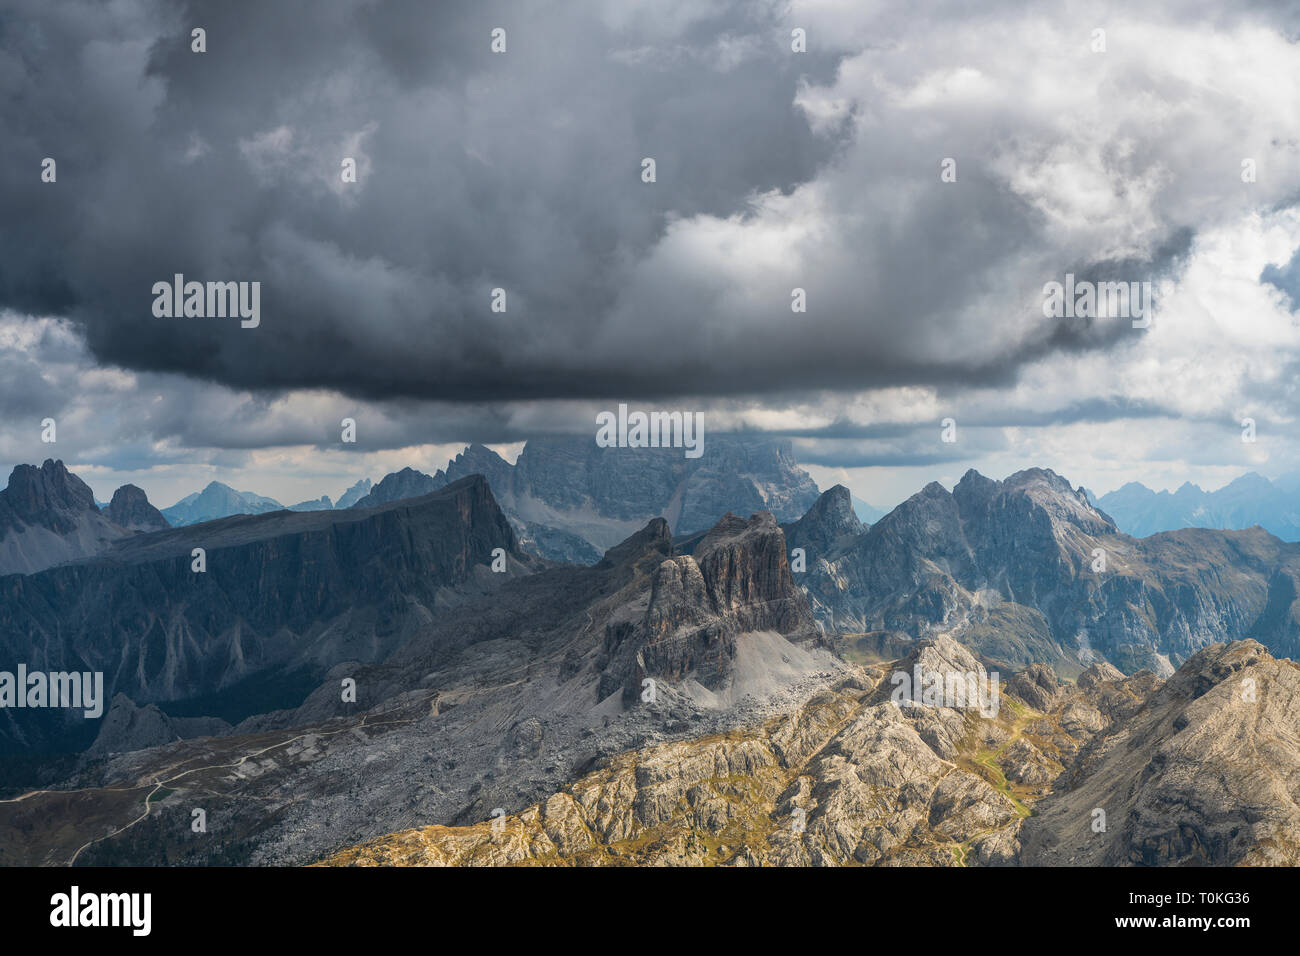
[0,477,523,749]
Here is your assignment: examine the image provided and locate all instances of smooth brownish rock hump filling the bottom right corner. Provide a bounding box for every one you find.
[1022,641,1300,866]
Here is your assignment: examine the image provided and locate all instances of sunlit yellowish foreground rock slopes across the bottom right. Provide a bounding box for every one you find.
[312,637,1300,866]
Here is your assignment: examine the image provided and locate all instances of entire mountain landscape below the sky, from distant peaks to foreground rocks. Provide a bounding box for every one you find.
[0,446,1300,865]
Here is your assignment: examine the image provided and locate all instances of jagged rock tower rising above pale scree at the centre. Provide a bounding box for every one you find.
[598,512,818,702]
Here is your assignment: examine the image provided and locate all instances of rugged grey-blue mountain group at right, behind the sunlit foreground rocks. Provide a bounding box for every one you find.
[787,468,1300,676]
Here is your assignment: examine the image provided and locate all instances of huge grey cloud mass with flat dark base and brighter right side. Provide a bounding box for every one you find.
[0,1,1295,402]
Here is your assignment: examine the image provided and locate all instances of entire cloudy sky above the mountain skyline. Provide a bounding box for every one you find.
[0,0,1300,506]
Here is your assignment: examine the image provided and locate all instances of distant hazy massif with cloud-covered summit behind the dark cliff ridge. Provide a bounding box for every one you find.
[0,436,832,574]
